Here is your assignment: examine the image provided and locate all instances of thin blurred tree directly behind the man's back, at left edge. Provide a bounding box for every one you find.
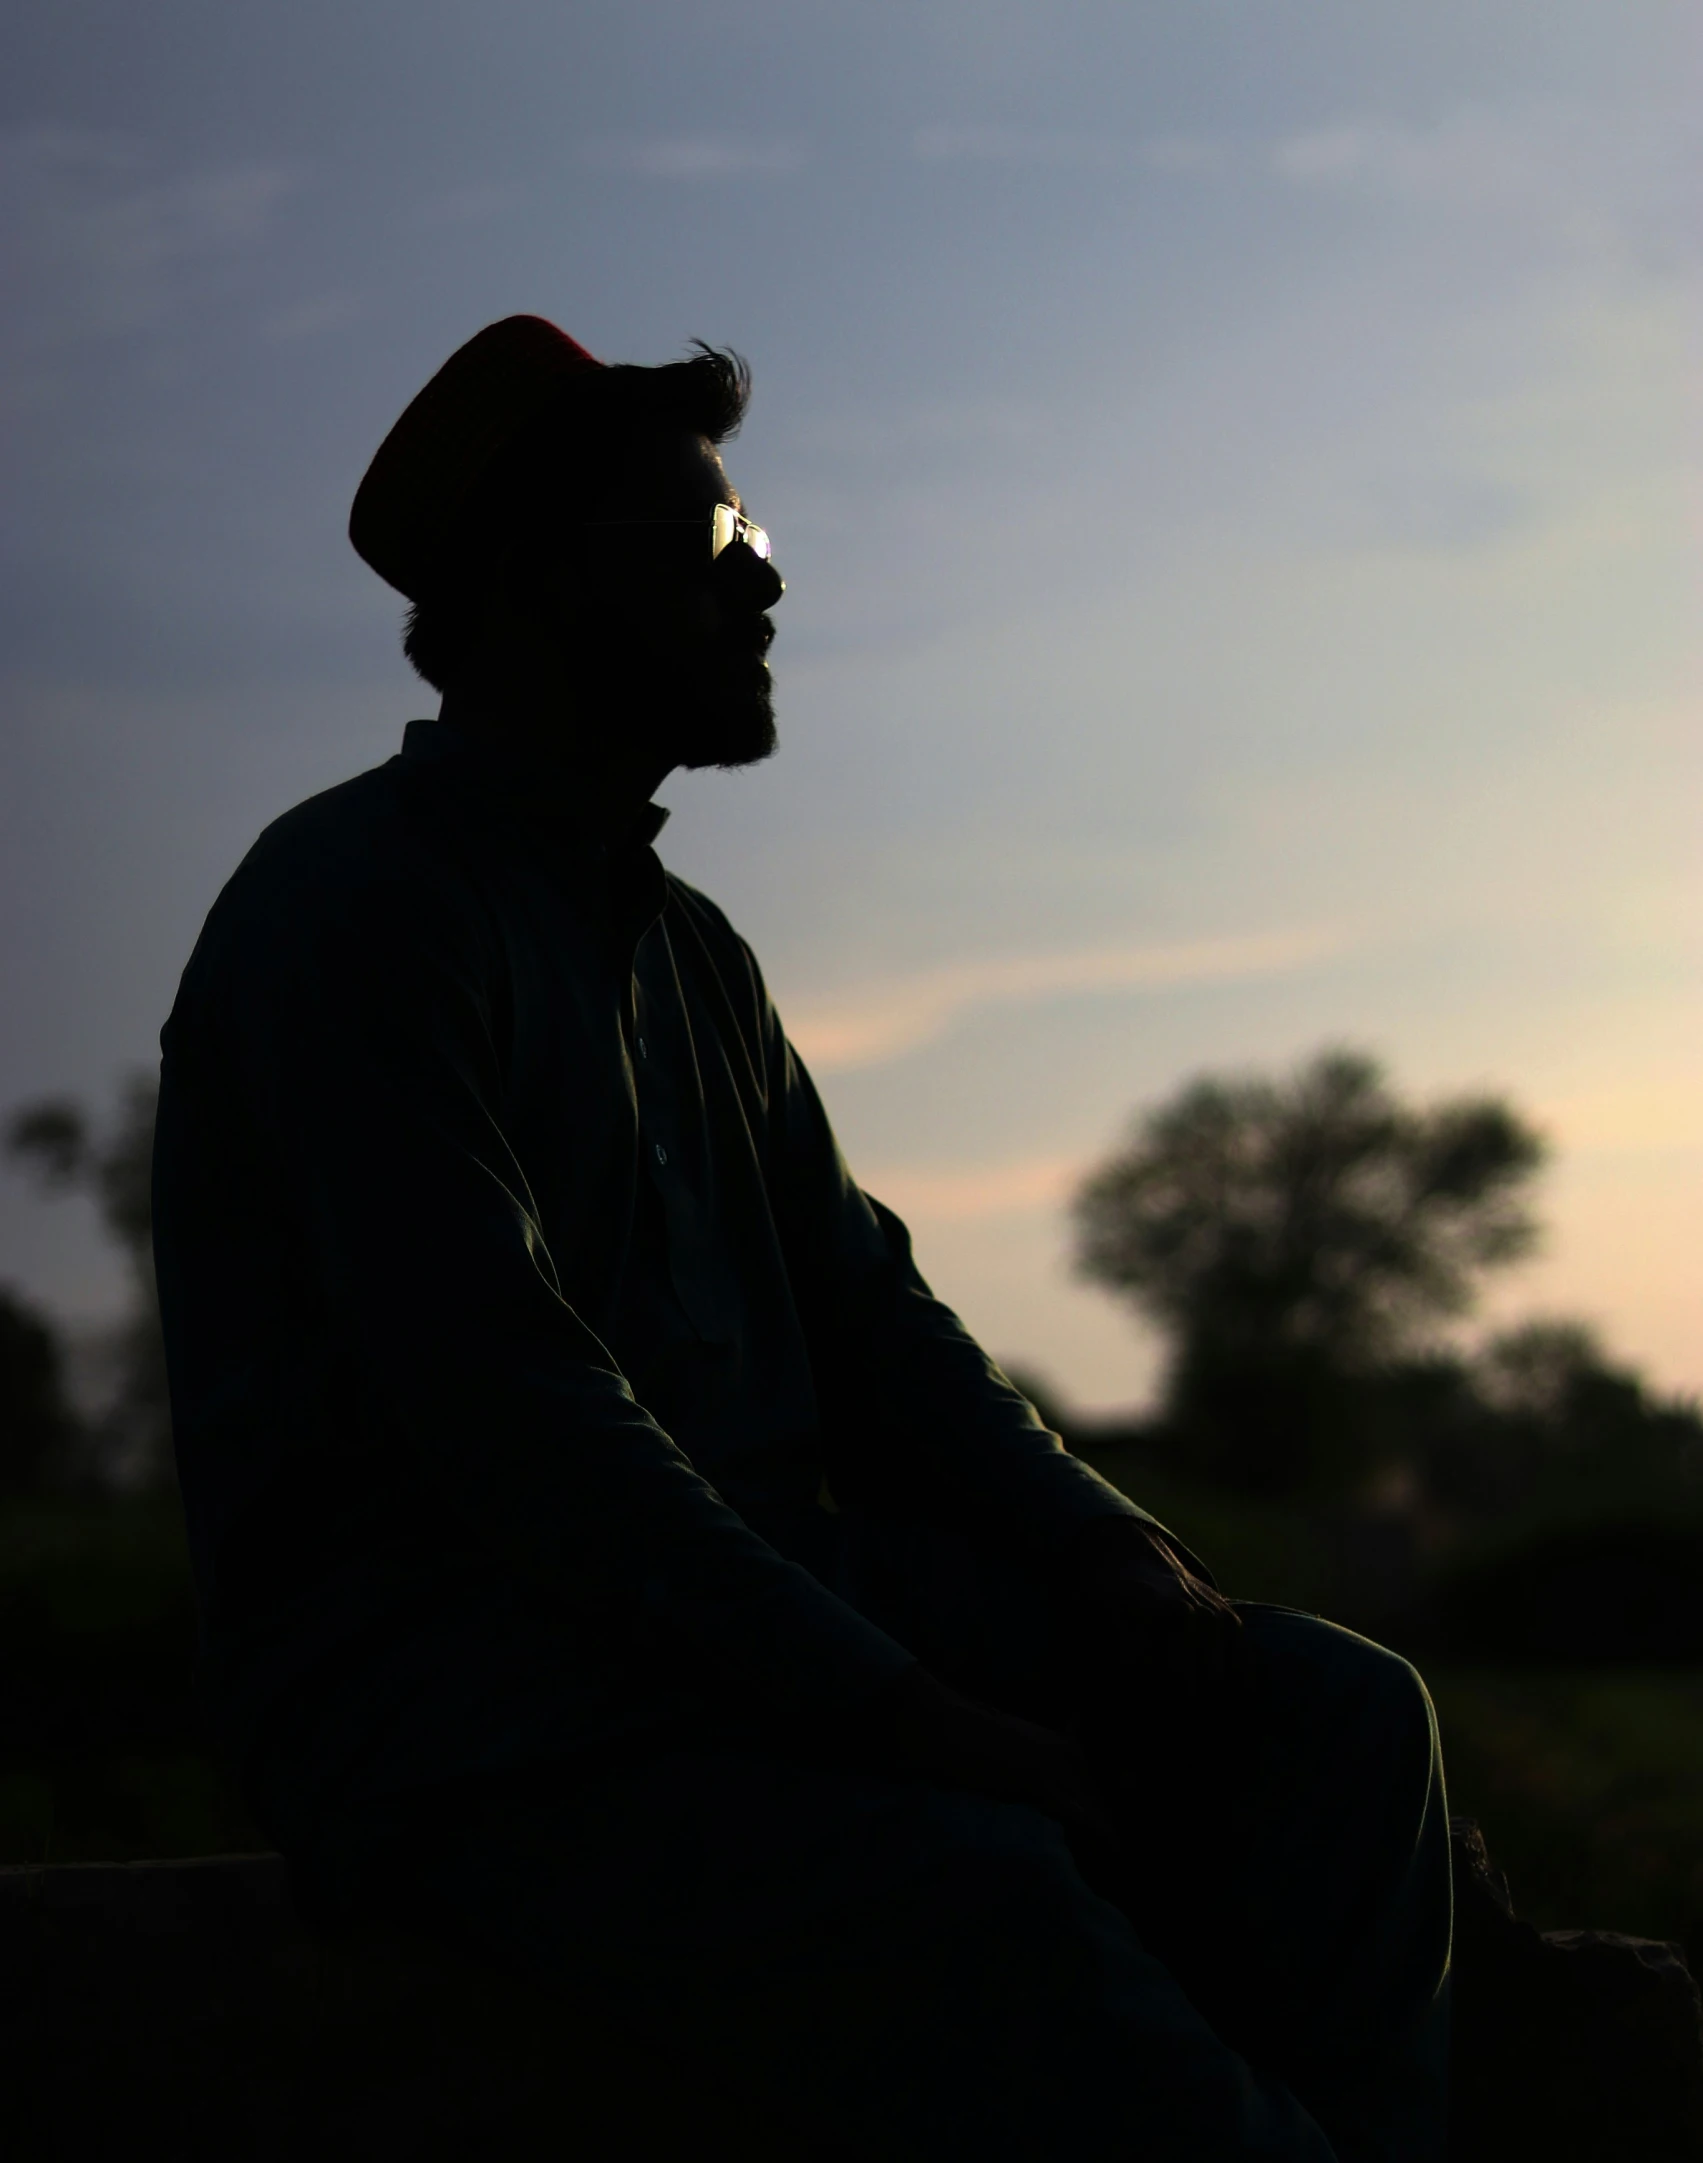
[4,1073,171,1486]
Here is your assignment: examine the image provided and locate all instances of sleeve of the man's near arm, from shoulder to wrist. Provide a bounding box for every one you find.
[167,834,915,1720]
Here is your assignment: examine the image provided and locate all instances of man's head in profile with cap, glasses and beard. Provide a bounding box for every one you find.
[351,318,783,770]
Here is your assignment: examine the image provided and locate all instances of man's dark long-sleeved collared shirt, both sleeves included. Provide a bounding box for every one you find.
[154,722,1143,1828]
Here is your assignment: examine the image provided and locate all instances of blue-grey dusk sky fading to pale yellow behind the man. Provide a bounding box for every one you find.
[0,0,1703,1408]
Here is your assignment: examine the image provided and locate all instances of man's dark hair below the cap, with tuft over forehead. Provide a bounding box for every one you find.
[402,337,751,692]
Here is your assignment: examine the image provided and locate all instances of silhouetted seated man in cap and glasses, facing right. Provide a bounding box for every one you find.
[156,316,1450,2163]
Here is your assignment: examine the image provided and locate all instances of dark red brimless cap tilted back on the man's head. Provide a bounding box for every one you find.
[348,316,604,601]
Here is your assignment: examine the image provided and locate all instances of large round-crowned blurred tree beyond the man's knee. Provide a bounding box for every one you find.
[1075,1051,1545,1492]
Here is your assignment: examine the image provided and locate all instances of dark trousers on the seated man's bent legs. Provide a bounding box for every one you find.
[300,1505,1450,2163]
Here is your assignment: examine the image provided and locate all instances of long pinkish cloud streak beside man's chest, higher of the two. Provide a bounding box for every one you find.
[788,930,1346,1073]
